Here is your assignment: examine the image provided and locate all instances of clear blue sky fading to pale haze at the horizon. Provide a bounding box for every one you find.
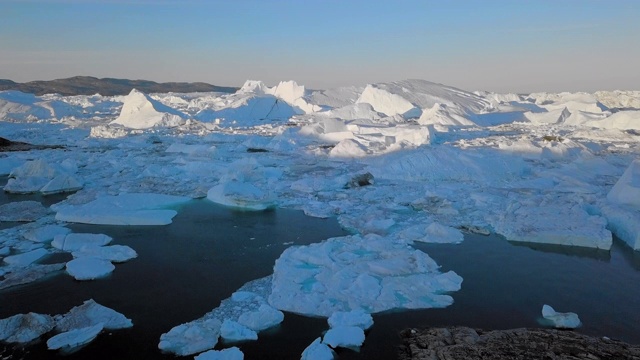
[0,0,640,93]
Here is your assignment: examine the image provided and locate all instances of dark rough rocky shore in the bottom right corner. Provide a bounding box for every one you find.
[399,327,640,360]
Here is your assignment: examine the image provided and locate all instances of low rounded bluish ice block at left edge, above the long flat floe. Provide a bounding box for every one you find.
[4,159,83,195]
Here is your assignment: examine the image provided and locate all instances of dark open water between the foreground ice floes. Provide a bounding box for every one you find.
[0,194,640,360]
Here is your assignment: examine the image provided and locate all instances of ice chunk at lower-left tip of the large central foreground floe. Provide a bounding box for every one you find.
[158,319,221,356]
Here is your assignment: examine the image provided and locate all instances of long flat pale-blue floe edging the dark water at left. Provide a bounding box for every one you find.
[52,193,191,225]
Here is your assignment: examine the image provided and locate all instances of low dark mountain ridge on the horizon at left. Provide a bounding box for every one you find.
[0,76,238,96]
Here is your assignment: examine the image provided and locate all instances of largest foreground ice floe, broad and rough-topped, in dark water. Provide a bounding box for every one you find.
[269,234,462,317]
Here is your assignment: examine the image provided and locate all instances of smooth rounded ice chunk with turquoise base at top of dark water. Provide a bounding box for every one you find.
[207,180,275,211]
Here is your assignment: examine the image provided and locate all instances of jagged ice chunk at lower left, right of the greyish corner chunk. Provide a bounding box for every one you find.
[55,299,133,332]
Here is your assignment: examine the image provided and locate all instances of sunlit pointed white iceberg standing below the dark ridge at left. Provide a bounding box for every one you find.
[111,89,187,129]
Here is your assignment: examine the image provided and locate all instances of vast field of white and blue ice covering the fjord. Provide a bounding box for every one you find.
[0,80,640,359]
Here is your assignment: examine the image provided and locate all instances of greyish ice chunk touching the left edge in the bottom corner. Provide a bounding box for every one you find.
[0,313,55,344]
